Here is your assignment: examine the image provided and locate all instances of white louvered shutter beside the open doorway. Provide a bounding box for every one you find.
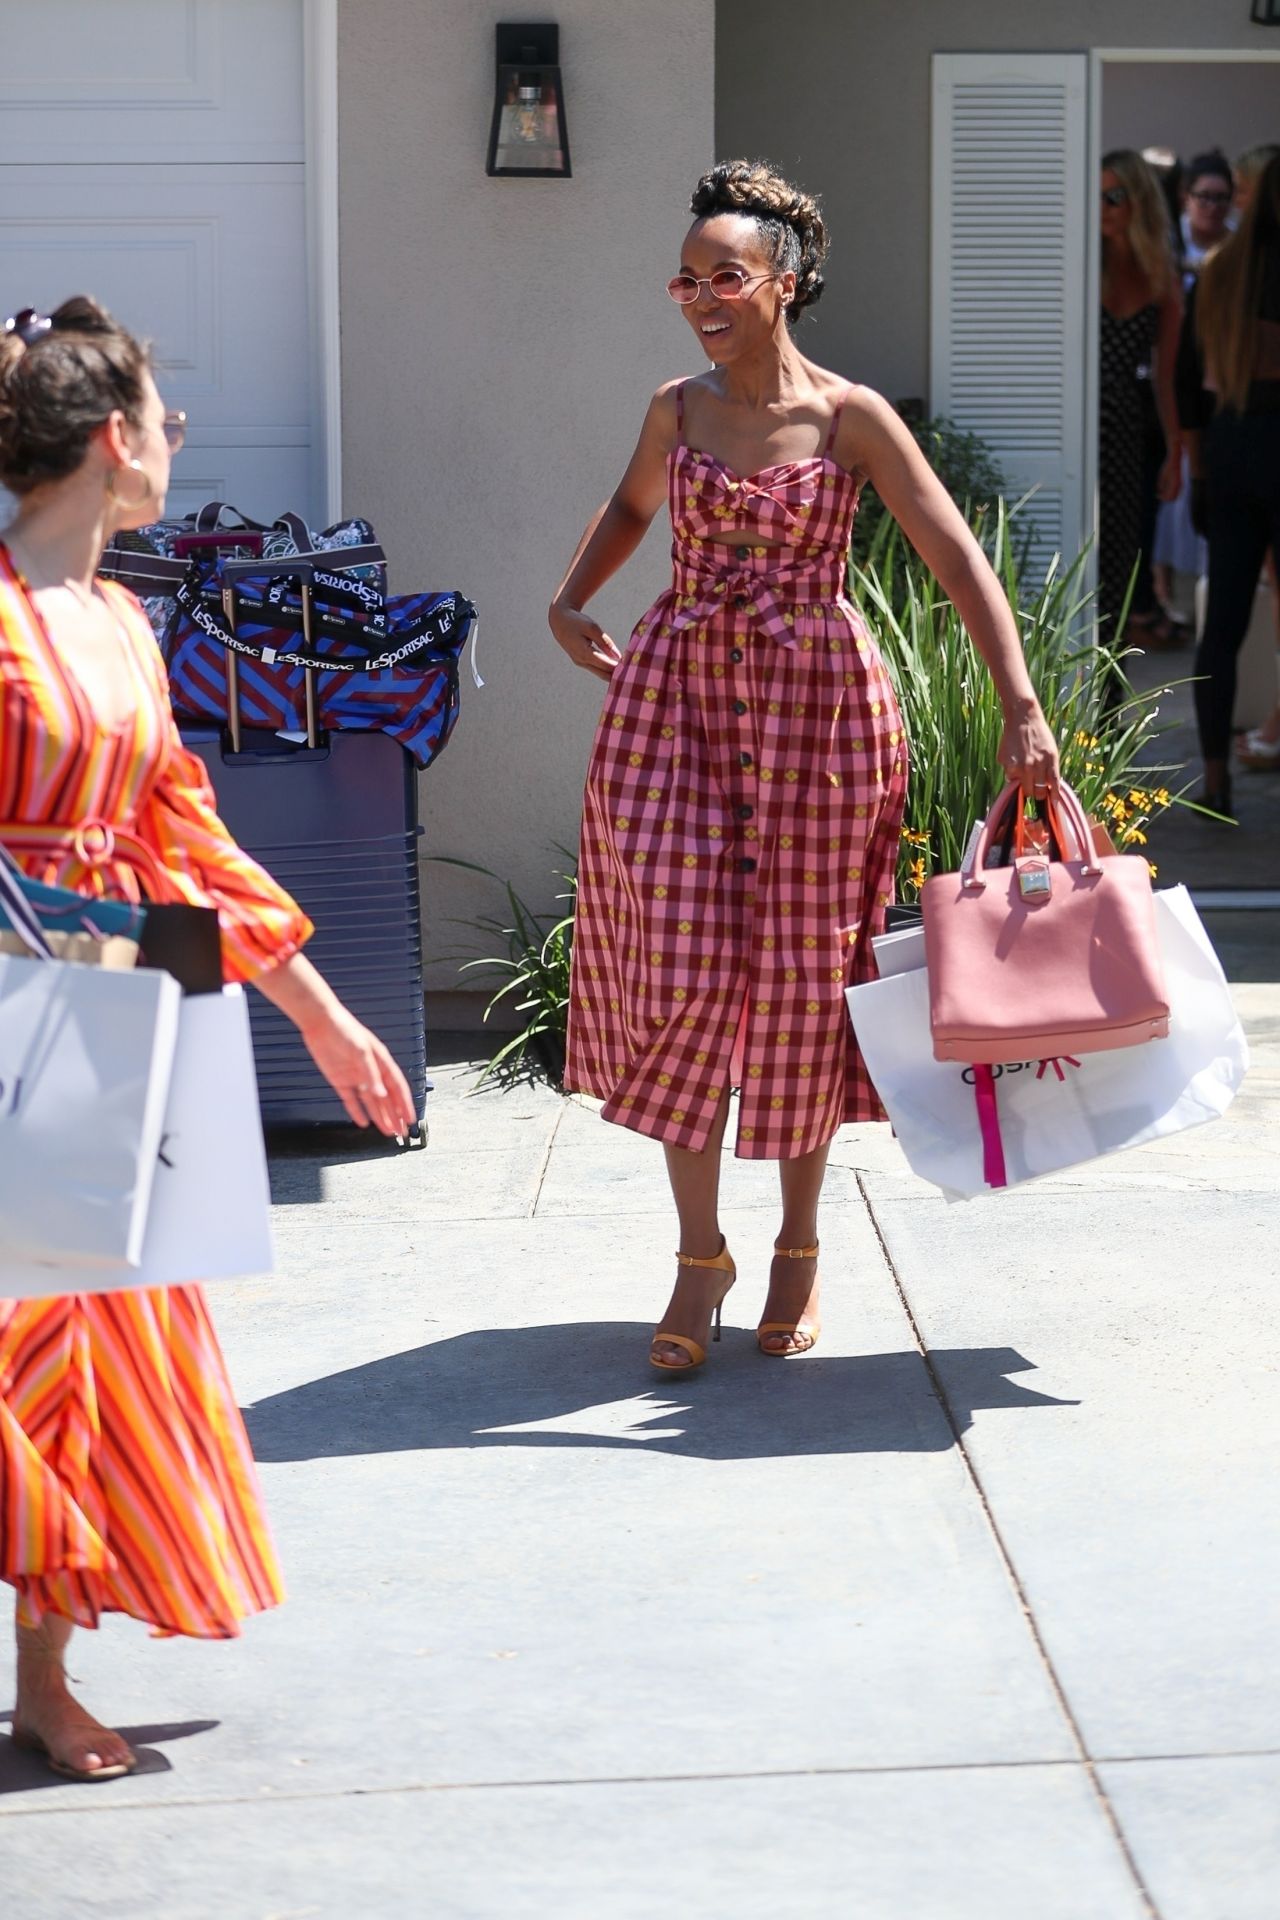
[931,54,1088,568]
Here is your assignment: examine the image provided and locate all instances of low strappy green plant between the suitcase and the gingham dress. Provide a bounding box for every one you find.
[436,847,578,1087]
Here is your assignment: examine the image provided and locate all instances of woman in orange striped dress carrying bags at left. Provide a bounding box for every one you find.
[0,298,415,1780]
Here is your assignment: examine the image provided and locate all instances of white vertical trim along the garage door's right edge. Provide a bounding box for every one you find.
[303,0,342,524]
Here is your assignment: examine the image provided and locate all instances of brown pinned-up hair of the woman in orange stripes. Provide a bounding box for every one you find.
[0,294,152,493]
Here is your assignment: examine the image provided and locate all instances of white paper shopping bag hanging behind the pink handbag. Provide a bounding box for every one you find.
[846,887,1249,1200]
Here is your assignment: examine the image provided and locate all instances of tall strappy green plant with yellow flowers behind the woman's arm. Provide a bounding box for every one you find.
[852,499,1173,904]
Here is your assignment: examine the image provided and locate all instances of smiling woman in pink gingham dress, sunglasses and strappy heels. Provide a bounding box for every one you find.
[551,161,1057,1371]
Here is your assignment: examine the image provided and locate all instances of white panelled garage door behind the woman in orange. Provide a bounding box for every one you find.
[0,0,320,518]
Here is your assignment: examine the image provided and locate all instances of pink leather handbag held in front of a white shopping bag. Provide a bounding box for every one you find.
[921,787,1169,1066]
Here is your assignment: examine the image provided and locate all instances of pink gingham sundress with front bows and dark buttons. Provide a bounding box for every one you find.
[564,388,906,1160]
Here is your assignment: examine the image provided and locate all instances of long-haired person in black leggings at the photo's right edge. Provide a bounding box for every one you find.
[1176,157,1280,814]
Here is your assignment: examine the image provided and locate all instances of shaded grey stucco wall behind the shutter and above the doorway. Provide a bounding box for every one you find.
[716,0,1280,412]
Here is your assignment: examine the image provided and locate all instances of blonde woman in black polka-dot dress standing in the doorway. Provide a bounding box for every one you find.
[1098,148,1182,660]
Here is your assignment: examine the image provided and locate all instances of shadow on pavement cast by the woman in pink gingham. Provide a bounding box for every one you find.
[244,1321,1079,1461]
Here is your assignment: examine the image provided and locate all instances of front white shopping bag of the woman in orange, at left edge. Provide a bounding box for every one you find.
[0,954,180,1284]
